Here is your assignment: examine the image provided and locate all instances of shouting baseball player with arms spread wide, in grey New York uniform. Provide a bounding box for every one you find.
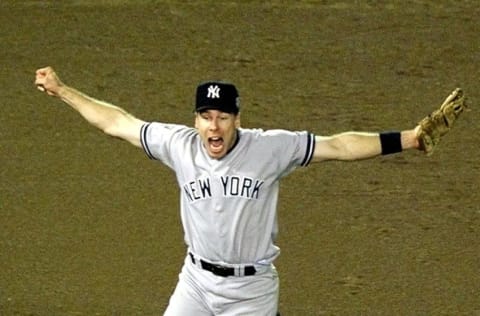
[35,67,465,316]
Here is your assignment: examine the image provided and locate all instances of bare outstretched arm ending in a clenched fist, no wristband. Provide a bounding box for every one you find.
[35,67,145,147]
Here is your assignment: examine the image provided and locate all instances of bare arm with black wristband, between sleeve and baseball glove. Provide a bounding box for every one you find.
[312,127,419,162]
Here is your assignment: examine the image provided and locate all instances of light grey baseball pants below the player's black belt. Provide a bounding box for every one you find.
[164,256,279,316]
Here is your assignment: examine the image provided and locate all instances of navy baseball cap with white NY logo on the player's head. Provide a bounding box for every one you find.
[195,81,240,114]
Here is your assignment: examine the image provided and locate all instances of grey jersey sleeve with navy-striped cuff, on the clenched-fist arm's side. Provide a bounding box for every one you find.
[140,122,192,168]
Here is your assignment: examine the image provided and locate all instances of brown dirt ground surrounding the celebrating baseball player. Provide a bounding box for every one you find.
[0,0,480,316]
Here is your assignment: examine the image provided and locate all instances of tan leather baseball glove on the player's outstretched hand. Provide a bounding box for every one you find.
[417,88,467,155]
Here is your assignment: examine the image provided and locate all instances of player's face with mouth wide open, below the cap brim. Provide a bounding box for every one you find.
[195,110,240,159]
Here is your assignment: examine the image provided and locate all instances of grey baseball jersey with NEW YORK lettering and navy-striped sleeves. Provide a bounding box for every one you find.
[141,122,315,264]
